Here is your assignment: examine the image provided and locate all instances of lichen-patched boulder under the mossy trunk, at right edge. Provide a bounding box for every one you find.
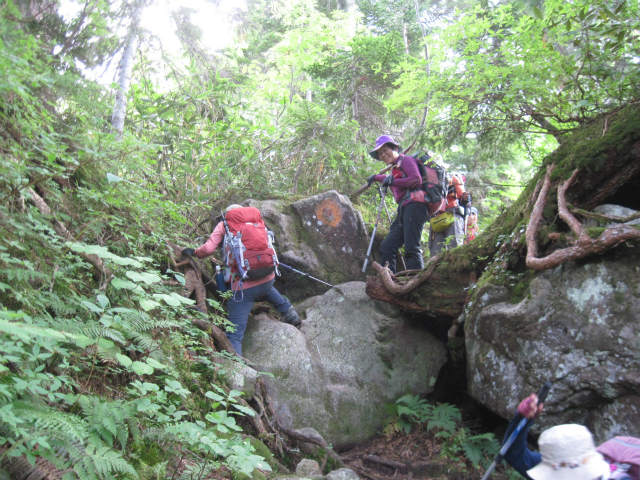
[465,245,640,440]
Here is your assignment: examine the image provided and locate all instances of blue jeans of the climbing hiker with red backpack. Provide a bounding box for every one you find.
[226,280,291,355]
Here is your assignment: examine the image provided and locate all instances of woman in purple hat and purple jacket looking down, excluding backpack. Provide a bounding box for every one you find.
[368,135,429,273]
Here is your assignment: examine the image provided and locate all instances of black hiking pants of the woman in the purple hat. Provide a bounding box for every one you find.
[380,202,429,273]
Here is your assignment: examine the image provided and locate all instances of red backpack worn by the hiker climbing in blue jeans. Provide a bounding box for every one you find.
[222,207,278,282]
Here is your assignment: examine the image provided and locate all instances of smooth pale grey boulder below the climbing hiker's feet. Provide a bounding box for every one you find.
[243,282,446,447]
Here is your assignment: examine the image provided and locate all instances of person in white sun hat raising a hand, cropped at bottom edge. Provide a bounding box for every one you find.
[504,393,640,480]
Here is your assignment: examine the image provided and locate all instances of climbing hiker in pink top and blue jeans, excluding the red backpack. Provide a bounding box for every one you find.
[182,205,301,355]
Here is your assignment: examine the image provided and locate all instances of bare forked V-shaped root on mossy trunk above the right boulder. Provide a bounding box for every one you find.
[526,165,640,270]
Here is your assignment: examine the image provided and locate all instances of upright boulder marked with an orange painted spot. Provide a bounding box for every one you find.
[244,190,369,301]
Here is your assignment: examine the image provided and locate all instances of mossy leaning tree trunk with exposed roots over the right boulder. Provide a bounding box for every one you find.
[367,105,640,320]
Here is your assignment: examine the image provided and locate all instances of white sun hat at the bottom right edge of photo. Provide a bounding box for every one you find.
[527,423,610,480]
